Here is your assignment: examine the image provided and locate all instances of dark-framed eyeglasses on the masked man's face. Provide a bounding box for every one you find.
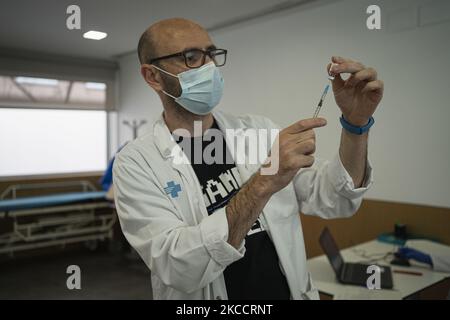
[150,49,227,69]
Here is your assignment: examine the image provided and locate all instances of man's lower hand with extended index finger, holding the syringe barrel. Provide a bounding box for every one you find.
[260,118,327,194]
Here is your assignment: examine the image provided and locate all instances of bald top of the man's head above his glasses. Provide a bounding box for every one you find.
[138,18,211,64]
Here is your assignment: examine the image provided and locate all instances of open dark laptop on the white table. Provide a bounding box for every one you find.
[319,228,393,289]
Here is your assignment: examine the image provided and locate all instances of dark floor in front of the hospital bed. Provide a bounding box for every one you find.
[0,249,152,300]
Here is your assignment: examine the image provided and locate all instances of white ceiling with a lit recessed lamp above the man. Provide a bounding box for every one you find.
[0,0,301,60]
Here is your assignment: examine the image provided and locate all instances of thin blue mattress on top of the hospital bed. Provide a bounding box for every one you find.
[0,191,106,211]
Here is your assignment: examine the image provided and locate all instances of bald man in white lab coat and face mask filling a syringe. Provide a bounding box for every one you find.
[113,18,383,299]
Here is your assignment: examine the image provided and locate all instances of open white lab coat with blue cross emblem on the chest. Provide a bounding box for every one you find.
[113,112,372,299]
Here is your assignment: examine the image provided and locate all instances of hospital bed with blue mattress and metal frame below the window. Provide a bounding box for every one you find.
[0,181,116,255]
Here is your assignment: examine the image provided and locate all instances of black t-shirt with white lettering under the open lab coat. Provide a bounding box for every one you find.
[174,121,290,300]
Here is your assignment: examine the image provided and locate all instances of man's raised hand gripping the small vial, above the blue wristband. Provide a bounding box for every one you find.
[327,57,384,127]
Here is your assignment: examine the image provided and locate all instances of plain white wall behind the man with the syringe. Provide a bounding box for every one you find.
[119,0,450,207]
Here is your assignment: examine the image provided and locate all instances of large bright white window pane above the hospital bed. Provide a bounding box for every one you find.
[0,108,107,177]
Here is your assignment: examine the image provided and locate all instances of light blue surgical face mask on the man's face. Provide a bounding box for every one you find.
[153,62,223,115]
